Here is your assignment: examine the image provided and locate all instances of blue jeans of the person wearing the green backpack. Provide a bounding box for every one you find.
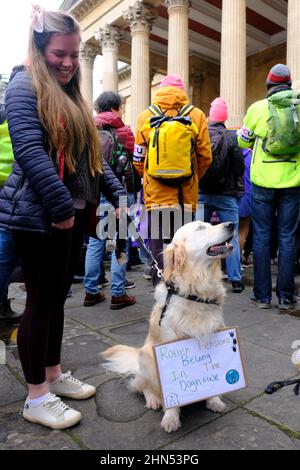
[251,184,300,302]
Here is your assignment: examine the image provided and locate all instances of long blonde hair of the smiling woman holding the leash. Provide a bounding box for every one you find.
[26,11,102,176]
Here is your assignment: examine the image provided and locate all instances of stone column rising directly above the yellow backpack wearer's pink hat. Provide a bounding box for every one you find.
[165,0,190,93]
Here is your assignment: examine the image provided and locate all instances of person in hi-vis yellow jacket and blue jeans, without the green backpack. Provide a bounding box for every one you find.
[238,64,300,310]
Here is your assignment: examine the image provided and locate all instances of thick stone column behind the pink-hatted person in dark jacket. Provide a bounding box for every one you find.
[220,0,246,127]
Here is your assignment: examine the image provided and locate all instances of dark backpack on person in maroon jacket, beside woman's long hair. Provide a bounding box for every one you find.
[98,127,141,194]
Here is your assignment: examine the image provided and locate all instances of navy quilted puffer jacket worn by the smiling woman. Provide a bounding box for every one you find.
[0,67,125,232]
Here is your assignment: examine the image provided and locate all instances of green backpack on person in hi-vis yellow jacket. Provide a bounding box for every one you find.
[263,90,300,157]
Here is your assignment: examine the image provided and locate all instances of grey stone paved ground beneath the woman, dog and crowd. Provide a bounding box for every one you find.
[0,268,300,450]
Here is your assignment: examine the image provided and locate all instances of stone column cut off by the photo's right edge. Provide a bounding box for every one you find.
[287,0,300,90]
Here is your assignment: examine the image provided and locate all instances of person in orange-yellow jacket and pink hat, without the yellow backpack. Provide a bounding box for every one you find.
[133,75,212,285]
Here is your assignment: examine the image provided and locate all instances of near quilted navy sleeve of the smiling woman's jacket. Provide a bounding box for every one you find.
[6,71,74,223]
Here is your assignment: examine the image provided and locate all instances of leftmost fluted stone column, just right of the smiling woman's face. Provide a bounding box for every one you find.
[80,42,97,109]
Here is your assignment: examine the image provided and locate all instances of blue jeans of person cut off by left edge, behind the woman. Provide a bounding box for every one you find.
[0,228,18,304]
